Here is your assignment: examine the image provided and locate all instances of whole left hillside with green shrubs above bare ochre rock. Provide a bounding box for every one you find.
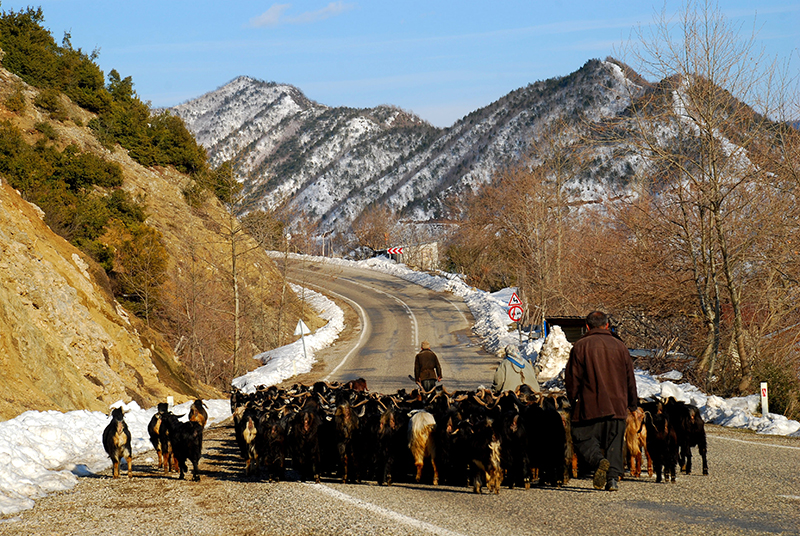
[0,9,317,416]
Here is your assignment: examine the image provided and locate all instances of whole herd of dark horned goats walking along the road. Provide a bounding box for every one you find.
[103,380,708,493]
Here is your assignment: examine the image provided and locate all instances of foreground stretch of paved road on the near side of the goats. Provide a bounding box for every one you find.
[0,425,800,536]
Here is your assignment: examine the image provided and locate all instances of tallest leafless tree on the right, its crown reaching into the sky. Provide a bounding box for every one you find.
[620,1,800,392]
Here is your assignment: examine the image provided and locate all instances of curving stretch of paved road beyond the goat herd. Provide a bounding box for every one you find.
[277,259,496,393]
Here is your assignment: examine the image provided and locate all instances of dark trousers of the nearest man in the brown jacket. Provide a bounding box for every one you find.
[572,418,625,478]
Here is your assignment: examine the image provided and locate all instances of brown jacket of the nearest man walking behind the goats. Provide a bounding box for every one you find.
[564,328,639,422]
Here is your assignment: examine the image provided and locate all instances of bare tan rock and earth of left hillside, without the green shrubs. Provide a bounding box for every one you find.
[0,62,294,419]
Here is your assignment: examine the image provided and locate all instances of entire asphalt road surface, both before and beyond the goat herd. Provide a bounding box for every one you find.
[0,258,800,536]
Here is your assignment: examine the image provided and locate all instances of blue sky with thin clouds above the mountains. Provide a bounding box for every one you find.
[0,0,800,127]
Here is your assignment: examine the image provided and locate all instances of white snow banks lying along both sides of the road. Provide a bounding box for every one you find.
[0,253,800,523]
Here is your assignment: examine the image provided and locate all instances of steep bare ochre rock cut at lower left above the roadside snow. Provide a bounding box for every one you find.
[0,184,175,417]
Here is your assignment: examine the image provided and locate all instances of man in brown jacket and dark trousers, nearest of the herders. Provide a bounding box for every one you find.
[565,311,639,491]
